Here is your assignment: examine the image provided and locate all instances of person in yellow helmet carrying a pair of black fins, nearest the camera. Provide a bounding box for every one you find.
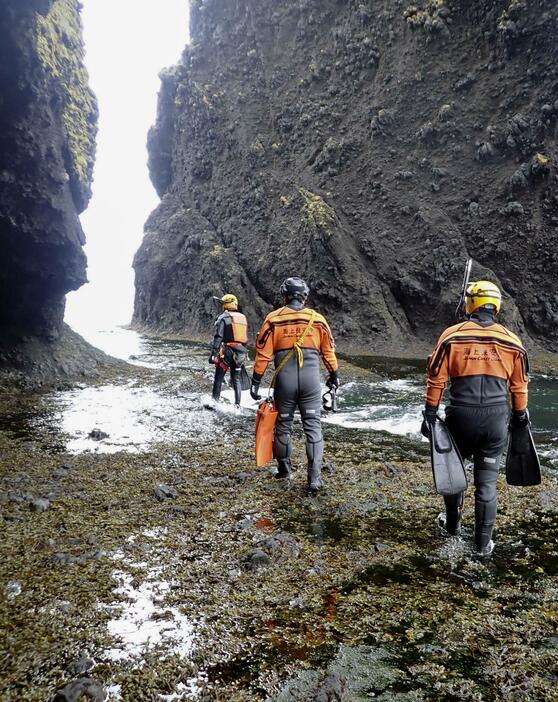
[421,280,529,556]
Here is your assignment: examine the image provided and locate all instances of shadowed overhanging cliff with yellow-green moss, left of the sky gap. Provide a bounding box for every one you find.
[0,0,97,344]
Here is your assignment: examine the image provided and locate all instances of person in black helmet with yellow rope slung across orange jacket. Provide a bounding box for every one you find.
[250,278,339,491]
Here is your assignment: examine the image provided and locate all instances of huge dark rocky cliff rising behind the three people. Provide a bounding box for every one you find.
[134,0,558,351]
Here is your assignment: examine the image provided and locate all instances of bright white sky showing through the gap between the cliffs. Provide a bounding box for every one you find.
[66,0,189,333]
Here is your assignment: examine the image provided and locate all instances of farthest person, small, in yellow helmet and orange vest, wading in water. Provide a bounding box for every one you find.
[209,294,248,407]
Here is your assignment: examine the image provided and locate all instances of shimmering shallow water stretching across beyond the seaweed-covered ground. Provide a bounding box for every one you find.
[2,328,558,468]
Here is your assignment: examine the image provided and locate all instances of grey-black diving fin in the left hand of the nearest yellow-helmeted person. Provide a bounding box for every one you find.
[430,417,467,495]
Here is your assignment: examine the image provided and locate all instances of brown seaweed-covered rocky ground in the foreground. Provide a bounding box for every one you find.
[0,354,558,702]
